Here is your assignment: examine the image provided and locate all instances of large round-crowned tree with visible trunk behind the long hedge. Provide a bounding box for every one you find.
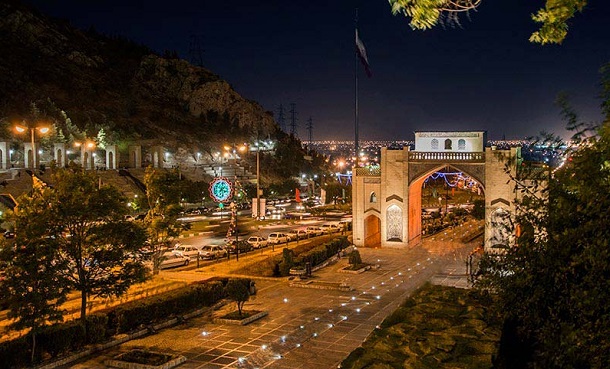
[43,167,147,322]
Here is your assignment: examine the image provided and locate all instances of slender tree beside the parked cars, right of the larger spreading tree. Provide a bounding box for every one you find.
[144,167,185,274]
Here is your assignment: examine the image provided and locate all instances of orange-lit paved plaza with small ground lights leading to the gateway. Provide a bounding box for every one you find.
[62,229,474,369]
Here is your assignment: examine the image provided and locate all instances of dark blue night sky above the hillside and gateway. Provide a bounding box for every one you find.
[23,0,610,140]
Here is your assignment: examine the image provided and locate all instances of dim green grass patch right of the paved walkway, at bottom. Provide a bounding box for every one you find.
[341,284,501,369]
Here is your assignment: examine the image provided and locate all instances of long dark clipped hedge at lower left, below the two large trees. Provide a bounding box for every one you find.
[0,280,226,369]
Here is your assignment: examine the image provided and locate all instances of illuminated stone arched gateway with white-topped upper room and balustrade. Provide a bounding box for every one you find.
[352,131,521,249]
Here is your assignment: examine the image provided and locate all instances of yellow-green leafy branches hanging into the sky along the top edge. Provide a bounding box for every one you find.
[388,0,587,45]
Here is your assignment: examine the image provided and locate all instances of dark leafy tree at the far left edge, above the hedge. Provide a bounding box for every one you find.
[0,188,69,362]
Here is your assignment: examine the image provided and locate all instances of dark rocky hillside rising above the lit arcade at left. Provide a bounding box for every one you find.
[0,0,280,149]
